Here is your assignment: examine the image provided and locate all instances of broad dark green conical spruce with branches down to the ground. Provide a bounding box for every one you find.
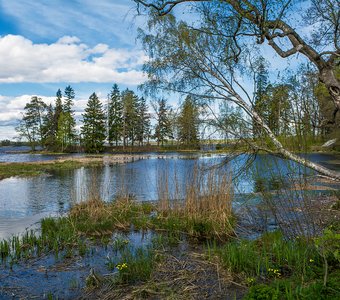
[81,93,106,153]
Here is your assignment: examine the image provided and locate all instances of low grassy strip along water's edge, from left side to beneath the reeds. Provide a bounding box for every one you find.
[0,197,231,264]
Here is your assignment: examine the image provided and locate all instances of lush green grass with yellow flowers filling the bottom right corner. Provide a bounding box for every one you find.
[207,232,340,299]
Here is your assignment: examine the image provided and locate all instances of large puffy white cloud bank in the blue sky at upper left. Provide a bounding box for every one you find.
[0,35,147,85]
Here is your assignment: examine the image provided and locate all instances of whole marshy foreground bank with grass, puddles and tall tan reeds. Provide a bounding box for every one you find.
[0,163,340,299]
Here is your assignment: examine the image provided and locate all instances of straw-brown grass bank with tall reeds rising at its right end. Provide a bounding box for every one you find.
[69,164,235,240]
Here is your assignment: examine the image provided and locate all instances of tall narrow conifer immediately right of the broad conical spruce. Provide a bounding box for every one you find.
[107,84,123,146]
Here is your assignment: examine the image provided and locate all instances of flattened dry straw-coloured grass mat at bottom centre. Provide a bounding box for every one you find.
[82,250,247,300]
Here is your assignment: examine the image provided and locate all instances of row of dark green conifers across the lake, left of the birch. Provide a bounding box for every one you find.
[16,84,199,153]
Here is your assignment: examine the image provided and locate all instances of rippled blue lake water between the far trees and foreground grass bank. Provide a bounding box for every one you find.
[0,148,340,239]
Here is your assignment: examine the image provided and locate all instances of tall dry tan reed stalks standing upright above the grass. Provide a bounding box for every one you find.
[157,165,233,236]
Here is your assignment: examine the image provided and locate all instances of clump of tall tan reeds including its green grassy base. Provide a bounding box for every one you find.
[156,166,234,239]
